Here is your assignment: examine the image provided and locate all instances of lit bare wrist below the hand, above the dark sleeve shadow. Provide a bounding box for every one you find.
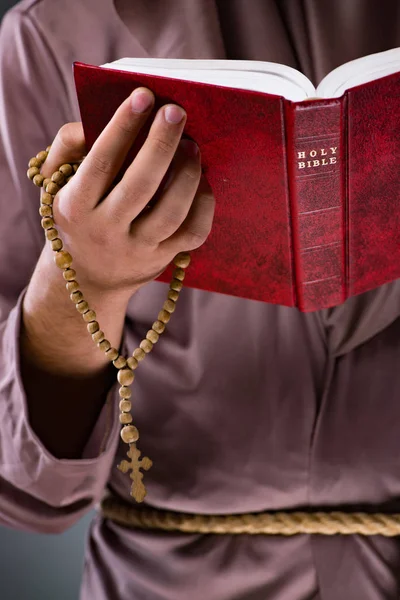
[21,248,129,376]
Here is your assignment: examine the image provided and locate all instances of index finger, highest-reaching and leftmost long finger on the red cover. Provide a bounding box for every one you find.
[70,88,154,210]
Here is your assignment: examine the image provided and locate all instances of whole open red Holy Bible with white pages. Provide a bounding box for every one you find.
[74,49,400,311]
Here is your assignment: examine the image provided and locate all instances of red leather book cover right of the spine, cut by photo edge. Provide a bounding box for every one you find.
[347,73,400,296]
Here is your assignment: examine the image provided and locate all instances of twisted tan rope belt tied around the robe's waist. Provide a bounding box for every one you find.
[100,496,400,537]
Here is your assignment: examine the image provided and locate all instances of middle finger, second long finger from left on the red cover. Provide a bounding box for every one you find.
[104,104,186,228]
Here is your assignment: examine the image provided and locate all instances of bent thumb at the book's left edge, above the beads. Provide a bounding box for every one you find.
[41,123,86,177]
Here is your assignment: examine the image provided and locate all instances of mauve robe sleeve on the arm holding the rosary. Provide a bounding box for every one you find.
[0,3,119,532]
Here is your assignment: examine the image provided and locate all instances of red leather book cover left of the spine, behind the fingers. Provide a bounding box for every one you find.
[74,63,294,306]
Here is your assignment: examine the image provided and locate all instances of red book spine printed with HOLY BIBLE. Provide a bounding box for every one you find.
[285,97,347,312]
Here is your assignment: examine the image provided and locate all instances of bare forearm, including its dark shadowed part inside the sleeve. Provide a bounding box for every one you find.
[20,246,129,458]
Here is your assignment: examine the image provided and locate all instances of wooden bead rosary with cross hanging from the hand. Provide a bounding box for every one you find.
[27,146,190,502]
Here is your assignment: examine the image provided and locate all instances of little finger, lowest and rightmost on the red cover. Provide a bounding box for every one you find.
[159,176,215,256]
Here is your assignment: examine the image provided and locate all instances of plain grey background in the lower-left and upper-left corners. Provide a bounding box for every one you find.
[0,0,93,600]
